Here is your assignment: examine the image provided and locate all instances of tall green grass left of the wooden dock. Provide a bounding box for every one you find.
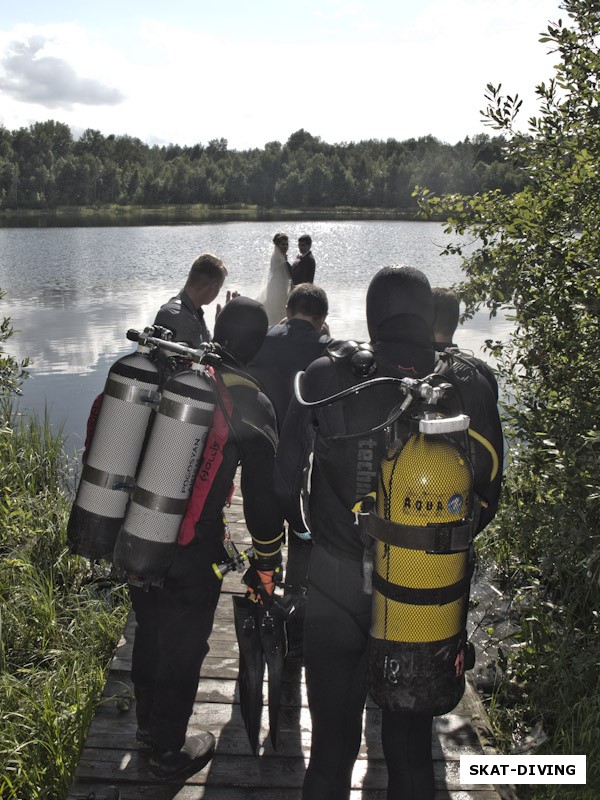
[0,407,128,800]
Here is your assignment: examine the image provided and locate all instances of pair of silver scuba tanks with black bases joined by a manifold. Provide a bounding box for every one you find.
[67,328,216,584]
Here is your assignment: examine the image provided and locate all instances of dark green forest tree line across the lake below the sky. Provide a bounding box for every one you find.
[0,120,525,210]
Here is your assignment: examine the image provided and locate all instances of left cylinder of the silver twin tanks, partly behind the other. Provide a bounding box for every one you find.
[67,343,159,559]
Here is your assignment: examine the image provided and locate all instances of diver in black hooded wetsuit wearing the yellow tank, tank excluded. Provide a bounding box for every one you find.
[276,267,502,800]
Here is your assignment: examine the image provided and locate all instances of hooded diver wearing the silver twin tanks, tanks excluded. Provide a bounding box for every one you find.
[129,297,282,778]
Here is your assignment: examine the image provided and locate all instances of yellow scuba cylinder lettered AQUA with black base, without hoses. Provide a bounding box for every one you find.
[367,406,473,715]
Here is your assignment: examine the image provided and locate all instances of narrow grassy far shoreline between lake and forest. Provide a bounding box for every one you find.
[0,204,440,228]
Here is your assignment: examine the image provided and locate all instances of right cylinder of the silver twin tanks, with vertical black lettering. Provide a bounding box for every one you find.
[113,363,215,583]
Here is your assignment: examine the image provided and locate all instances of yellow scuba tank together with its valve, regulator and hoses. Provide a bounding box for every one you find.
[295,354,478,715]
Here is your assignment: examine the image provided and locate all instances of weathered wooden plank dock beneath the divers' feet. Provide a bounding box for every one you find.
[68,496,515,800]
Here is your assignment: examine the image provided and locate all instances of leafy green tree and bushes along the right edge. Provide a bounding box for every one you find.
[418,0,600,798]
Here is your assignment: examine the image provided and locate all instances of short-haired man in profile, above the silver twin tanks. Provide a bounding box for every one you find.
[154,253,227,347]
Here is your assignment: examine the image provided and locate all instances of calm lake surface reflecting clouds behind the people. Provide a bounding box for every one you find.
[0,221,509,451]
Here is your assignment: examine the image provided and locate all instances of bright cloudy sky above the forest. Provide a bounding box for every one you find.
[0,0,566,150]
